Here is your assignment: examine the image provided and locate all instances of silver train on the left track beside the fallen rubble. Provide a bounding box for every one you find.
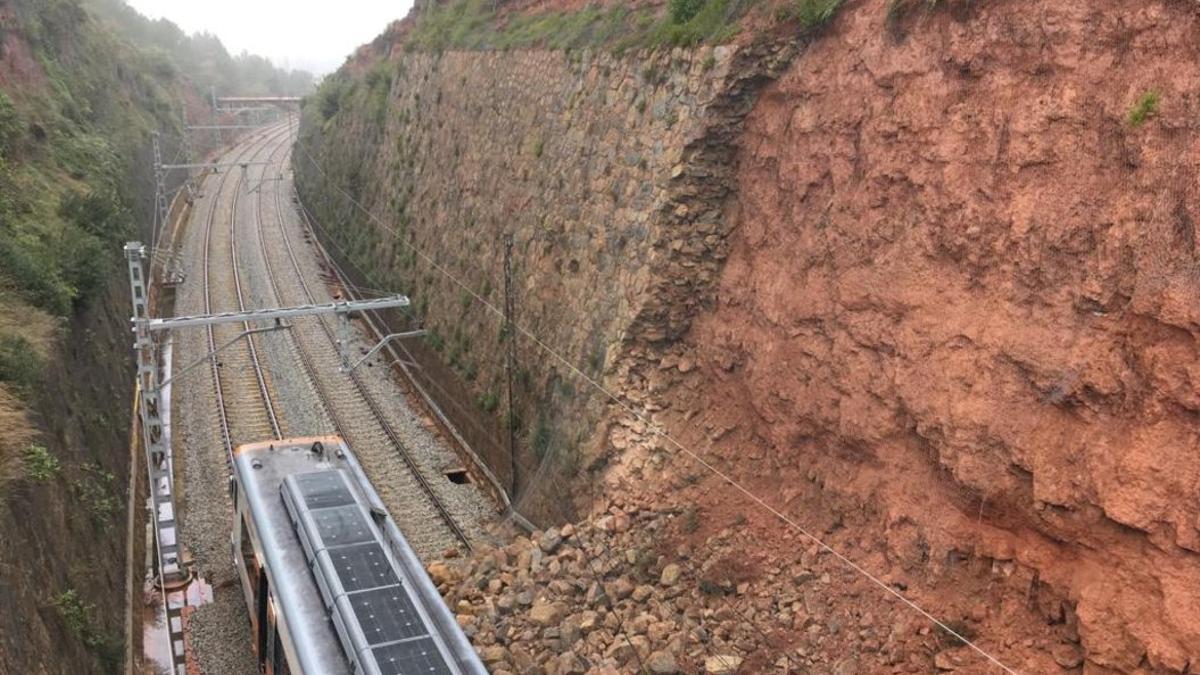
[230,436,487,675]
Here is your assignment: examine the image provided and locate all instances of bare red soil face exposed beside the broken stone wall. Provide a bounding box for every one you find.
[667,0,1200,673]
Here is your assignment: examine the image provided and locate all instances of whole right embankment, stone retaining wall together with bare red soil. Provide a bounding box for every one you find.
[296,0,1200,673]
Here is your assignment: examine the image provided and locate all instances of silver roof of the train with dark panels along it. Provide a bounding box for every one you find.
[238,437,486,675]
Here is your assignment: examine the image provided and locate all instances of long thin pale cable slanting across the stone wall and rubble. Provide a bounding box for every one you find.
[295,143,1019,675]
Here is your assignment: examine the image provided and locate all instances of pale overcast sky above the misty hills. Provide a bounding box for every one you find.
[126,0,413,74]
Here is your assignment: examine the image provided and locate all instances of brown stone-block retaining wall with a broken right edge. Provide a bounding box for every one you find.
[294,1,797,519]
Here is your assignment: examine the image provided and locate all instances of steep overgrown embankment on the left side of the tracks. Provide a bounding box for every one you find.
[0,0,309,674]
